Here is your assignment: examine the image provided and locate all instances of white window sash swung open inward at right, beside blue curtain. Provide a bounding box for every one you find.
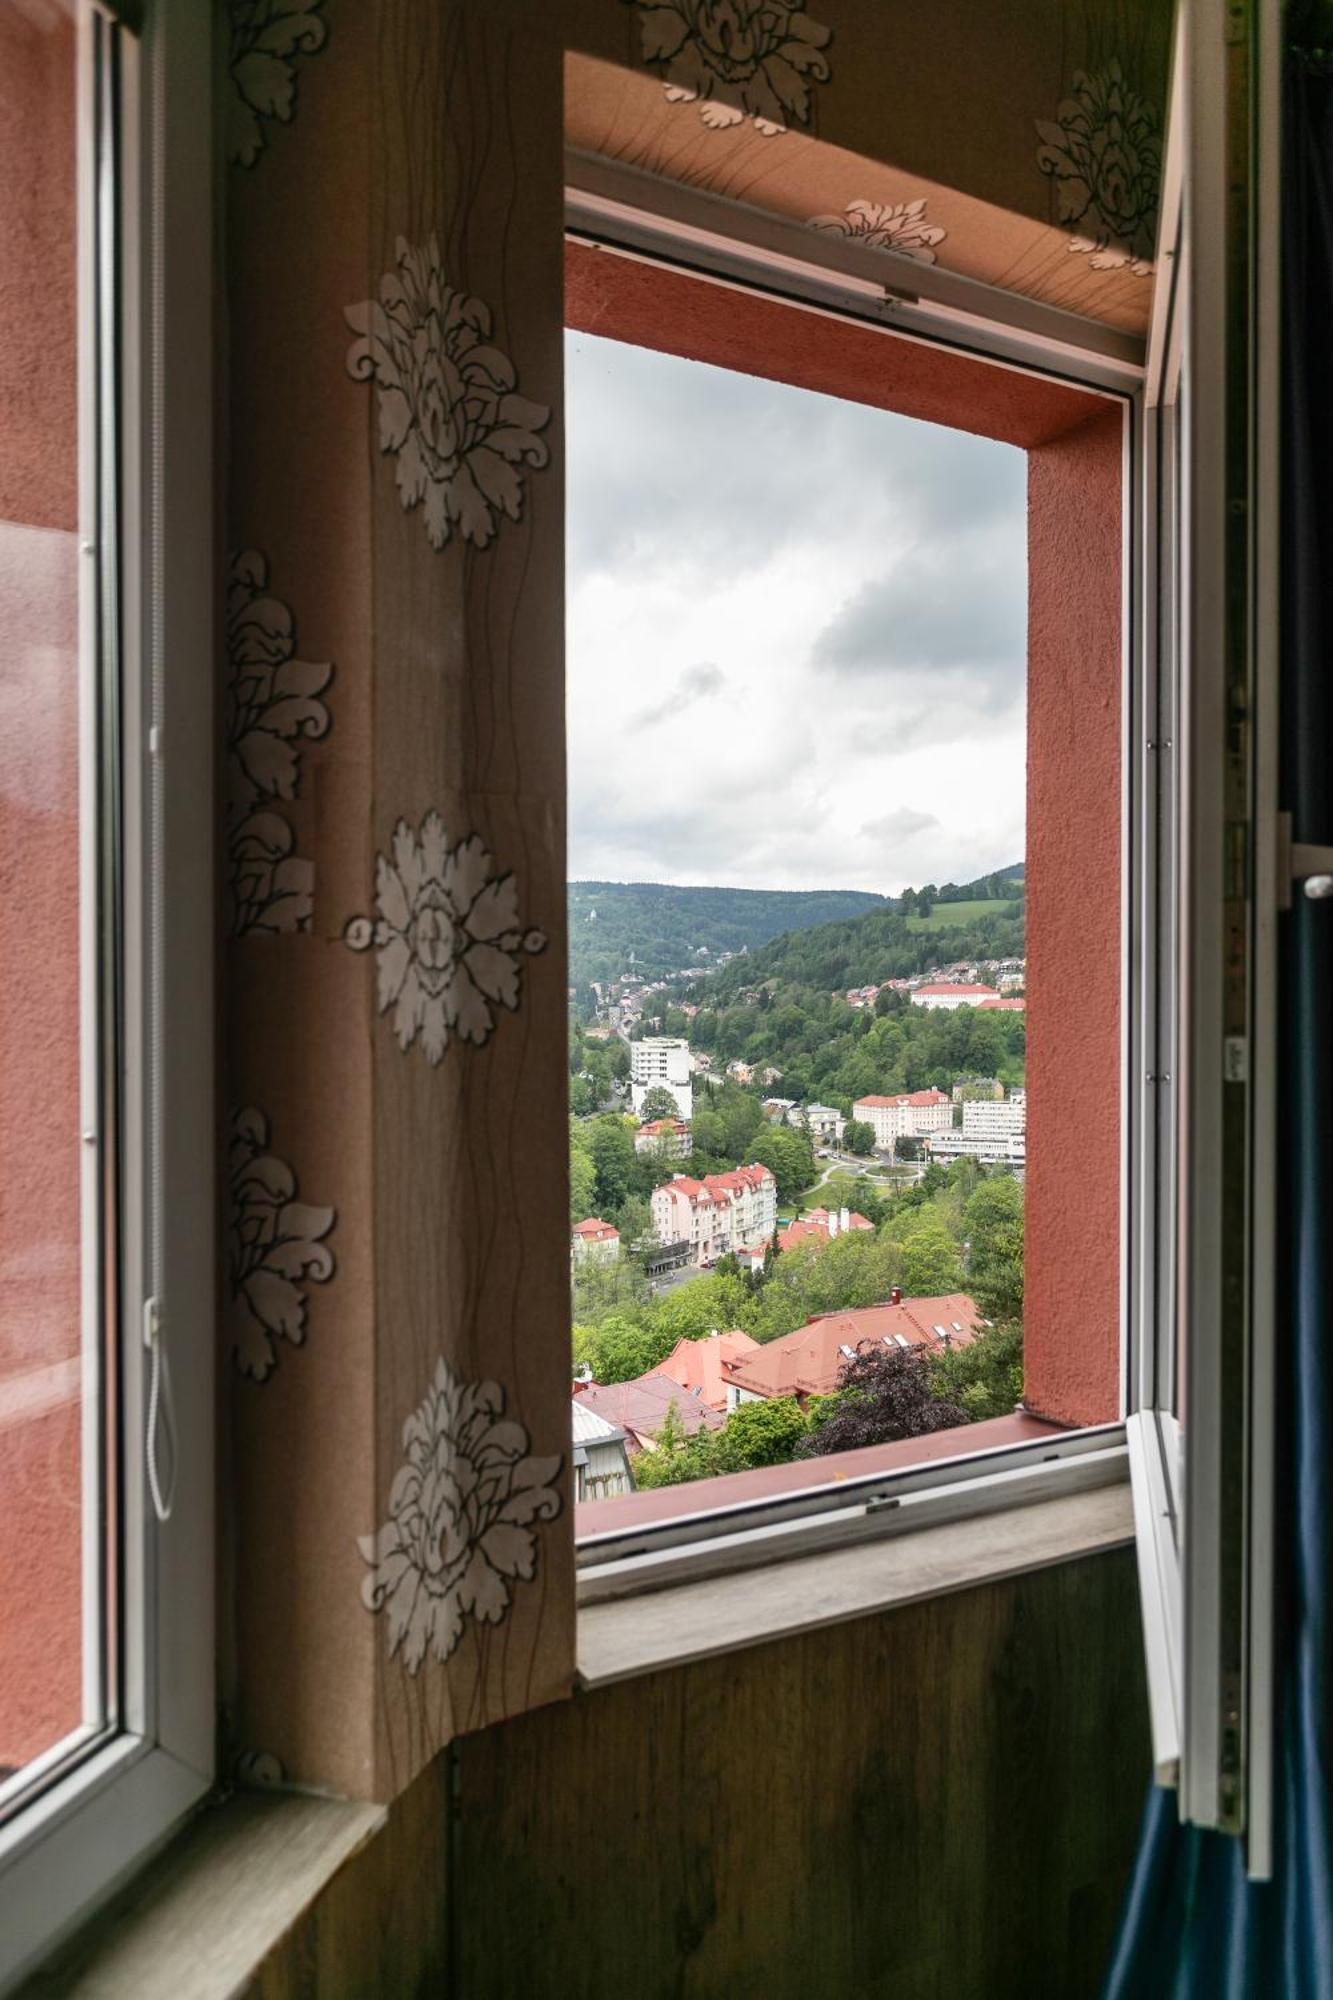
[1129,4,1291,1876]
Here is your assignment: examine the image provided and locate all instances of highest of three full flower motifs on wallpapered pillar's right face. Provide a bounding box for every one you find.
[344,236,550,548]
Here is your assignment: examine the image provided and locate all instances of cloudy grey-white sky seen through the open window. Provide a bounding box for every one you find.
[566,334,1027,894]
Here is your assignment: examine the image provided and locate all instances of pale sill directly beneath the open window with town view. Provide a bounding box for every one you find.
[578,1482,1135,1690]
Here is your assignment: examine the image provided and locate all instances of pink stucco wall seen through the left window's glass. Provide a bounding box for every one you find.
[0,6,82,1770]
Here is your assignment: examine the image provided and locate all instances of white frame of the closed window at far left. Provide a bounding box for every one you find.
[0,0,216,1992]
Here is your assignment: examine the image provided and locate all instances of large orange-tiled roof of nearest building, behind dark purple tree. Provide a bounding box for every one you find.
[727,1290,985,1410]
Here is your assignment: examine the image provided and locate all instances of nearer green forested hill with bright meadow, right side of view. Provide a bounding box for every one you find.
[707,884,1023,1008]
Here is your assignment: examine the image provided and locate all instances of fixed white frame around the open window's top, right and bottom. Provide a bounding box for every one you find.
[564,150,1145,1606]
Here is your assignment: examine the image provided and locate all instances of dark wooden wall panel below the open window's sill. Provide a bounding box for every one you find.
[452,1550,1149,2000]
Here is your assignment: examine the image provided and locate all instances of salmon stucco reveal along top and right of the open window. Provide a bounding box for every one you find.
[564,244,1123,1424]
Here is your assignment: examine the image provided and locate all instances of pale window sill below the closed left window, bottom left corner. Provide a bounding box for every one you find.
[24,1792,386,2000]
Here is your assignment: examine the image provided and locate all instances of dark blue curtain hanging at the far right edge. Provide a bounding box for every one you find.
[1105,58,1333,2000]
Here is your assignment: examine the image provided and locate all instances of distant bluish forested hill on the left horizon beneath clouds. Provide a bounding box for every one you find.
[568,882,889,988]
